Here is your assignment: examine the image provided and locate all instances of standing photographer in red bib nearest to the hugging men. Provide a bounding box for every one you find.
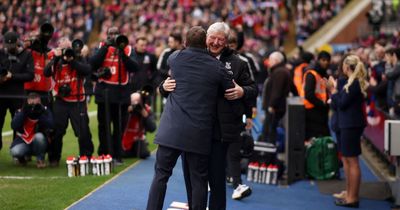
[89,27,140,164]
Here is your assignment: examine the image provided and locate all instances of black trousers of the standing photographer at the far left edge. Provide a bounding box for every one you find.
[0,98,24,150]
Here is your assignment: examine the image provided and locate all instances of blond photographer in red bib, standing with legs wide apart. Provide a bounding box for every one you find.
[44,37,93,166]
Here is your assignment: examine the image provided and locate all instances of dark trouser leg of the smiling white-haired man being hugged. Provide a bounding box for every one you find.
[208,140,228,210]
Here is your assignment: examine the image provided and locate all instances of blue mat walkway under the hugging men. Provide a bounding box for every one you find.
[70,155,390,210]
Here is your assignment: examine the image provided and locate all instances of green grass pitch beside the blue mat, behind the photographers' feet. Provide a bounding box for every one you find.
[0,99,156,209]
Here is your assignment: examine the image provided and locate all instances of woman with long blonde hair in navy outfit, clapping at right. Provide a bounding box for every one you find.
[328,55,368,208]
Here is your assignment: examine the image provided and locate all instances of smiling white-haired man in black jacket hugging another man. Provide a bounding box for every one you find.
[184,22,257,210]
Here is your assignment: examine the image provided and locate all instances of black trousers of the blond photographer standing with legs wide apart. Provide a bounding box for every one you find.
[49,99,93,161]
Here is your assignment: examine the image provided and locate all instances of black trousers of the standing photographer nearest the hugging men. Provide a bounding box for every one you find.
[97,103,128,159]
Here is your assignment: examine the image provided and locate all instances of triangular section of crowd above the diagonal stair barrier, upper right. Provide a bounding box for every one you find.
[296,0,349,45]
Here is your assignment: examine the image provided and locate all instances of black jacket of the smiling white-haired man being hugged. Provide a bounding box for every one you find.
[214,48,258,142]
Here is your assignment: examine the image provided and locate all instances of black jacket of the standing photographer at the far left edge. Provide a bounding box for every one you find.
[0,50,34,97]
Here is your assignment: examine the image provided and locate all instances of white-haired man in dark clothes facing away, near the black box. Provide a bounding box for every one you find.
[263,51,291,144]
